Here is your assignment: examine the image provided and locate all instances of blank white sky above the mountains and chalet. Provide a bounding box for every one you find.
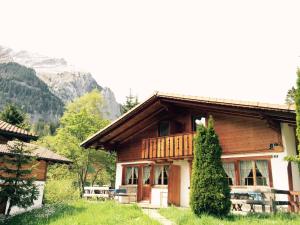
[0,0,300,103]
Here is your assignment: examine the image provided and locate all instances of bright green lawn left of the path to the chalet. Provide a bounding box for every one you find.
[0,200,159,225]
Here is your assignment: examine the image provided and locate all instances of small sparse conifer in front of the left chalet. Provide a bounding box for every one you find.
[0,141,39,217]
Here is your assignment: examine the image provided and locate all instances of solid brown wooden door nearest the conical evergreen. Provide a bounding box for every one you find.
[168,165,180,206]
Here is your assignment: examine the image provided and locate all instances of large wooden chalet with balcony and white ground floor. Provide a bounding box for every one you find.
[82,93,300,207]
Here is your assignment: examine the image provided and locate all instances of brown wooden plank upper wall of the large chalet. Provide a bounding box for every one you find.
[117,112,282,161]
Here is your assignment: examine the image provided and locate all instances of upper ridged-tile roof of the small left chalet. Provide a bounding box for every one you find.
[0,120,38,140]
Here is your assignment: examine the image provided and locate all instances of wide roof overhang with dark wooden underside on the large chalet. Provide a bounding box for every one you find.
[81,93,296,150]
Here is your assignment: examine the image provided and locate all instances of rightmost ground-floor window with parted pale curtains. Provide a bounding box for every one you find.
[240,160,269,186]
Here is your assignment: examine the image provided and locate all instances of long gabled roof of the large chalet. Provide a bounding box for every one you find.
[81,92,296,148]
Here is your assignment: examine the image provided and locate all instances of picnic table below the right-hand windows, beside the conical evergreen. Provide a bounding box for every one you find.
[230,191,266,212]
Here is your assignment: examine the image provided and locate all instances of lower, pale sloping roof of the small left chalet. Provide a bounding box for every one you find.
[0,141,72,164]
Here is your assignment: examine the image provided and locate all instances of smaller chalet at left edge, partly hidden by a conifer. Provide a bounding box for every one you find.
[0,120,72,214]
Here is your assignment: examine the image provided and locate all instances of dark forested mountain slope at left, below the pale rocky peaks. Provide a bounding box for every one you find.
[0,62,64,122]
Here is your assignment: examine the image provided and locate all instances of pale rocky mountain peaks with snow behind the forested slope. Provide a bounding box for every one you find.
[0,46,121,120]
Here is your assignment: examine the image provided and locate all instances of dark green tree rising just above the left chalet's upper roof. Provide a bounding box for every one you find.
[0,104,30,130]
